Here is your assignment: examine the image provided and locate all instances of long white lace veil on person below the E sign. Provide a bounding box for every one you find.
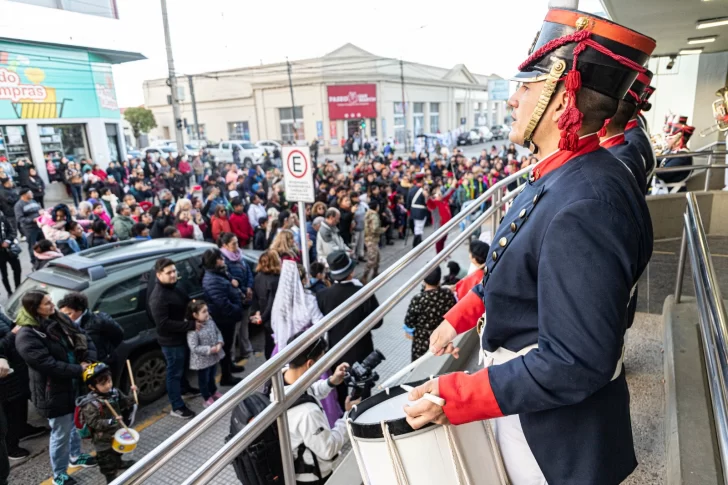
[271,260,311,352]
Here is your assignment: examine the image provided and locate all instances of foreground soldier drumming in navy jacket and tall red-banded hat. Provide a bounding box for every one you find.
[405,9,655,485]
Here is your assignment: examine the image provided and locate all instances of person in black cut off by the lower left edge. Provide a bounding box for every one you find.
[0,310,48,460]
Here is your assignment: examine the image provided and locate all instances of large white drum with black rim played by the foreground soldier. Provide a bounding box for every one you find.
[347,381,508,485]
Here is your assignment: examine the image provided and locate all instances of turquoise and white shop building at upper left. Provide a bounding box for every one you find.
[0,0,144,181]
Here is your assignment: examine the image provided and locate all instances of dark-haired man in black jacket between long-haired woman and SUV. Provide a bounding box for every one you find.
[58,291,124,368]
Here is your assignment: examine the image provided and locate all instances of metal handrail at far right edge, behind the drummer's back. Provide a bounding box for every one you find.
[682,193,728,485]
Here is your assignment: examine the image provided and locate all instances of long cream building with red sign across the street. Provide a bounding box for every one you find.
[144,44,508,151]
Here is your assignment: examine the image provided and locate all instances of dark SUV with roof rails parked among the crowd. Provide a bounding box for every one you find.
[6,239,260,403]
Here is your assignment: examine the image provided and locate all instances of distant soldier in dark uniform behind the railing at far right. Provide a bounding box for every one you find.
[652,116,695,195]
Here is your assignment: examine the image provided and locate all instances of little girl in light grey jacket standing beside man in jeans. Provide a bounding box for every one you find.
[185,300,225,407]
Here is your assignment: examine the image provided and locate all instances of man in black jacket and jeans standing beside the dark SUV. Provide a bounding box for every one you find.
[148,258,196,419]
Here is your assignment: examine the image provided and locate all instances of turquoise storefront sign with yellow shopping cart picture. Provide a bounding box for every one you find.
[0,42,119,120]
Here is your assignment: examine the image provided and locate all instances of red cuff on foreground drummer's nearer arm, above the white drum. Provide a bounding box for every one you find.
[438,368,503,424]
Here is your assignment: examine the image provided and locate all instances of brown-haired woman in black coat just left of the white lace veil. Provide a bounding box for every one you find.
[250,251,281,359]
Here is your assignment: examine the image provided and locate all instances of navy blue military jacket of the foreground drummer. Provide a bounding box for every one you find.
[440,139,653,485]
